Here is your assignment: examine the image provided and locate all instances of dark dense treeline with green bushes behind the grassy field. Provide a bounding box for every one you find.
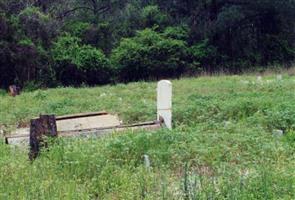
[0,0,295,87]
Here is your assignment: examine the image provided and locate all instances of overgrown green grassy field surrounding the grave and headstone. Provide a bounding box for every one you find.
[0,76,295,199]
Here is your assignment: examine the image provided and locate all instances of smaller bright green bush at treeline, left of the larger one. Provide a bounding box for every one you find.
[52,35,112,85]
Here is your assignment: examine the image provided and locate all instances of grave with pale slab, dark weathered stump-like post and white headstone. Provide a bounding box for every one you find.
[5,80,172,160]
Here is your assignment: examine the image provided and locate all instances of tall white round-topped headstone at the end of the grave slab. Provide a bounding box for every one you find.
[157,80,172,130]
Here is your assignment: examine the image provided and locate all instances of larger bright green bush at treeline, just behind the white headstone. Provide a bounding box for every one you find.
[112,29,192,81]
